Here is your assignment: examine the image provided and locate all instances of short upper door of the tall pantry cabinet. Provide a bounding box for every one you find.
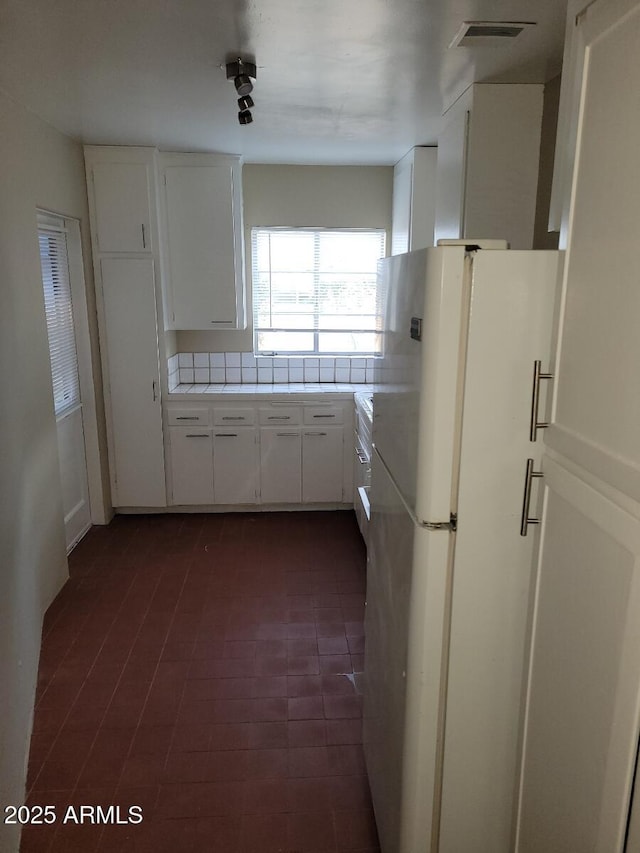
[92,163,151,252]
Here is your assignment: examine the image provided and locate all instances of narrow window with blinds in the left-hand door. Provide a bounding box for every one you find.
[38,213,80,415]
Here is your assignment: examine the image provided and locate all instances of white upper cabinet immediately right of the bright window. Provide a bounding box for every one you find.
[391,146,438,255]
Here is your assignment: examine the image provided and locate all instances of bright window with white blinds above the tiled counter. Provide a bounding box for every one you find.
[251,228,385,356]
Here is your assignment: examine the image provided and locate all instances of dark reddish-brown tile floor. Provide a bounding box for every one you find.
[21,512,378,853]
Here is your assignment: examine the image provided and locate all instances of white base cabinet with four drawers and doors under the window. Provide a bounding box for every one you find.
[166,400,352,507]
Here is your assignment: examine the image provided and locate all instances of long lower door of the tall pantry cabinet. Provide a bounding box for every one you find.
[100,258,166,507]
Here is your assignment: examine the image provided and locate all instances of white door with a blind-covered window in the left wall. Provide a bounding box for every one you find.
[38,212,91,551]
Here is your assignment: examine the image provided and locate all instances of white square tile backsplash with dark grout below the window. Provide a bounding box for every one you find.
[168,352,374,390]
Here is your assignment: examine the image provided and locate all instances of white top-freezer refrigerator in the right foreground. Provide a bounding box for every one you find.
[363,241,562,853]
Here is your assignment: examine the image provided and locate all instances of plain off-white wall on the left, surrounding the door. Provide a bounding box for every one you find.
[0,88,104,853]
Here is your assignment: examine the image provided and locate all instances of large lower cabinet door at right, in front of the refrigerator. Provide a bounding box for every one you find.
[516,457,640,853]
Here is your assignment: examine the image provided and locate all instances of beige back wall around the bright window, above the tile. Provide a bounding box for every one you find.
[176,165,393,352]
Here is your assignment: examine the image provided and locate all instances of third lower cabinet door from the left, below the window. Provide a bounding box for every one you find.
[260,428,302,503]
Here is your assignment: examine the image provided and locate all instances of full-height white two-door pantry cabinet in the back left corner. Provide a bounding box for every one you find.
[85,146,167,508]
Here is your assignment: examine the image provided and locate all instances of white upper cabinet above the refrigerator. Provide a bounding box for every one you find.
[435,83,543,249]
